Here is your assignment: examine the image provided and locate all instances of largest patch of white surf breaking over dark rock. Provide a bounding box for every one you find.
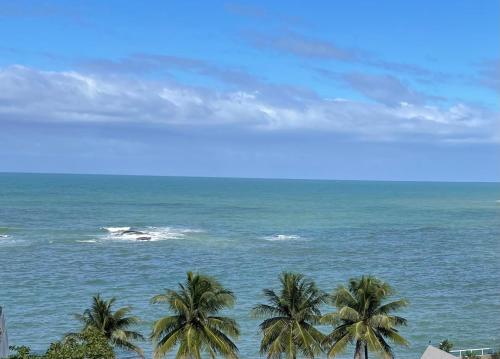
[102,227,204,242]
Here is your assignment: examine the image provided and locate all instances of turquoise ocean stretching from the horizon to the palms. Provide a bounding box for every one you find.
[0,174,500,358]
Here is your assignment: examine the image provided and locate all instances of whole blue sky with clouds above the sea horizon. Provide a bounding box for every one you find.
[0,0,500,181]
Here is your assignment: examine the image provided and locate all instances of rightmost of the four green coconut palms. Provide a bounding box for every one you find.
[321,276,408,359]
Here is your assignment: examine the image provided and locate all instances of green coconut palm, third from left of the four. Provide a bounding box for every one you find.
[252,272,327,359]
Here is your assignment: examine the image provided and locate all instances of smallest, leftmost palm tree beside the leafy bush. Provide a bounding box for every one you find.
[74,294,144,357]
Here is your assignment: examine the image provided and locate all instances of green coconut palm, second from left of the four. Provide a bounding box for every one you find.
[151,272,240,359]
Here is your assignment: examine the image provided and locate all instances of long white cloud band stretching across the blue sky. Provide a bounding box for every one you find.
[0,66,500,142]
